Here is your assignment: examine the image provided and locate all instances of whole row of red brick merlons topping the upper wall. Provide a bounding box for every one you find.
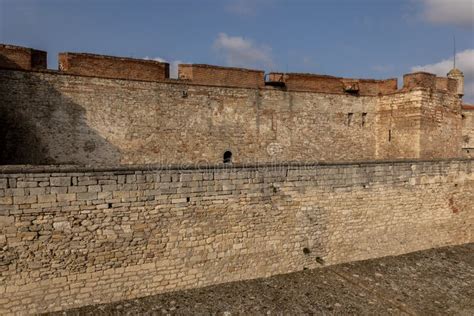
[0,45,463,97]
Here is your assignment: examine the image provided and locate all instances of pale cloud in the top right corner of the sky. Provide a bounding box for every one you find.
[422,0,474,28]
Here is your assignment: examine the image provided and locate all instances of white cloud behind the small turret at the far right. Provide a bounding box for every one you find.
[411,49,474,103]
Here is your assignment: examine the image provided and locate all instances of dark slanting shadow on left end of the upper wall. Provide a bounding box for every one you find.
[0,55,120,165]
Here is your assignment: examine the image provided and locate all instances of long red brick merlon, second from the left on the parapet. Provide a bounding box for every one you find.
[58,53,169,81]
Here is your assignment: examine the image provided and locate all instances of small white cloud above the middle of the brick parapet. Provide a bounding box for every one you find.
[213,33,273,67]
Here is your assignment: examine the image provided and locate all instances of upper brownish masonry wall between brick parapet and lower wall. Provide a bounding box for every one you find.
[0,70,461,165]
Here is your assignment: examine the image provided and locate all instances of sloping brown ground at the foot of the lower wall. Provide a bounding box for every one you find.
[49,243,474,316]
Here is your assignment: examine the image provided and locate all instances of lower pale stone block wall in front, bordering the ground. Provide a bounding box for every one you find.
[0,159,474,315]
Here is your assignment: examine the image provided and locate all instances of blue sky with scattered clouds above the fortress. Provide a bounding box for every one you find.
[0,0,474,102]
